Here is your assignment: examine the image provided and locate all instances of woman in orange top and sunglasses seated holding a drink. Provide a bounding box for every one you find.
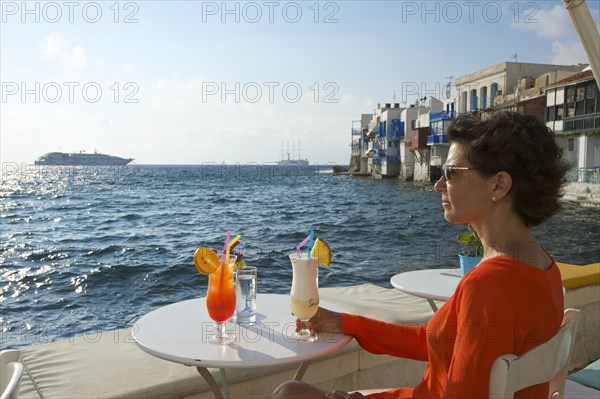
[273,112,568,399]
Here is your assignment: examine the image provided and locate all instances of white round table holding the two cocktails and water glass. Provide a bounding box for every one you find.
[132,294,352,398]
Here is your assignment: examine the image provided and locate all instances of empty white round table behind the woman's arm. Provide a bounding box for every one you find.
[390,269,460,312]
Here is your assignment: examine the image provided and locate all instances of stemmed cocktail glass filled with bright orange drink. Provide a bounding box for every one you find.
[206,255,237,345]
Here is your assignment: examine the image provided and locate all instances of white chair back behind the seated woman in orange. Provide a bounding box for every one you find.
[490,309,579,399]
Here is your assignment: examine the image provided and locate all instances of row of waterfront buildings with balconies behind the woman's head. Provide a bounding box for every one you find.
[352,62,600,183]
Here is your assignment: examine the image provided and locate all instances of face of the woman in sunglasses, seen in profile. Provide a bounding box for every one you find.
[435,142,492,224]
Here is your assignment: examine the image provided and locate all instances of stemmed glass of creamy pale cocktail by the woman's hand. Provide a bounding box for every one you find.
[289,253,319,341]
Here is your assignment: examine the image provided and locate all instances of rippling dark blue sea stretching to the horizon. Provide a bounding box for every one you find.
[0,164,600,349]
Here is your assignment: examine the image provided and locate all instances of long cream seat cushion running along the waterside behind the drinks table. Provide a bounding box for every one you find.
[15,284,433,399]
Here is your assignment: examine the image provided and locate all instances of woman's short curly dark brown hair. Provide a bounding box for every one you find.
[446,111,569,227]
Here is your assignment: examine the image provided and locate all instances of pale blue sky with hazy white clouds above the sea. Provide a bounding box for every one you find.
[0,0,600,165]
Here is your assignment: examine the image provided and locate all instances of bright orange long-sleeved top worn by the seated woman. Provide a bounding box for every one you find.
[342,256,564,399]
